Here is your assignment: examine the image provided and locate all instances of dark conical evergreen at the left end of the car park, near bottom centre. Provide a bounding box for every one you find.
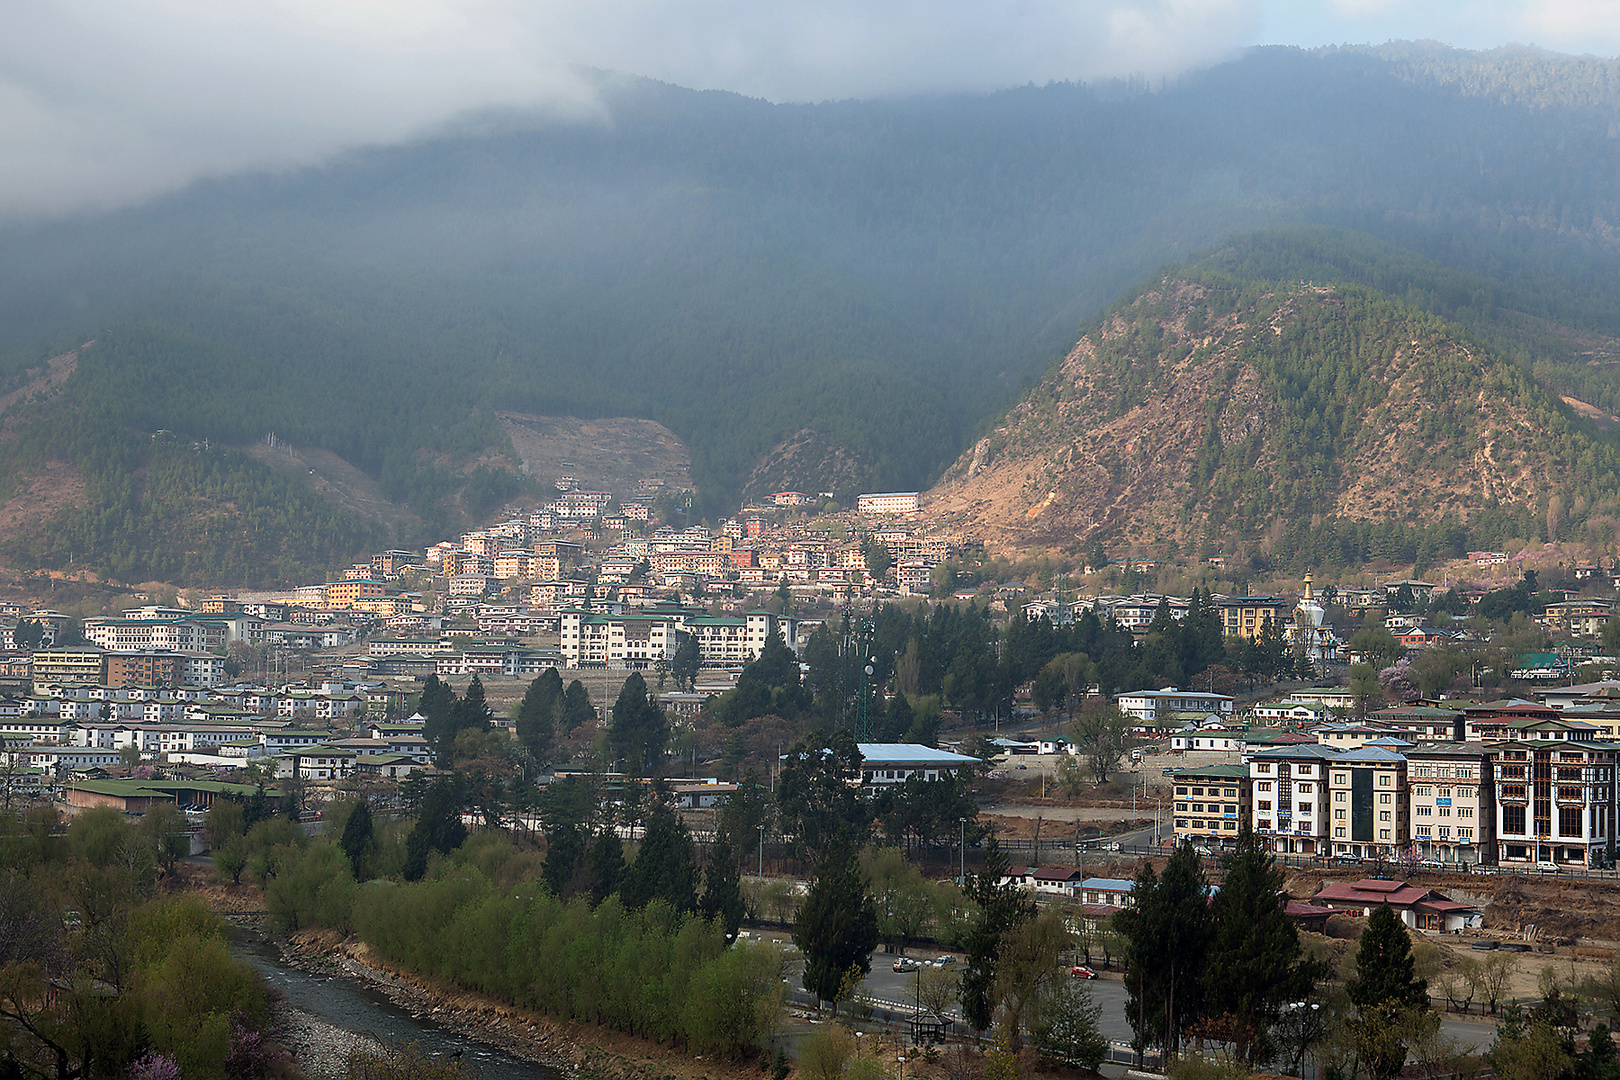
[794,832,878,1002]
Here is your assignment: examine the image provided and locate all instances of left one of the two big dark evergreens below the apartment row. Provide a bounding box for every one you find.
[1115,840,1210,1052]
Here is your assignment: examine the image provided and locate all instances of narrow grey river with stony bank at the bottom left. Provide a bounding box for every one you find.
[232,931,561,1080]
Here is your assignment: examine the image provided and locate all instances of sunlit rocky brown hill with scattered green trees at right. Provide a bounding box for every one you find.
[928,274,1617,563]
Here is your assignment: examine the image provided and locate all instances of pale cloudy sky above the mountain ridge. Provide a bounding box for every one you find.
[0,0,1620,219]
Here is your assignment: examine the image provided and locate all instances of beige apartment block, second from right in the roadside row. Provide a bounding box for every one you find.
[1406,742,1497,866]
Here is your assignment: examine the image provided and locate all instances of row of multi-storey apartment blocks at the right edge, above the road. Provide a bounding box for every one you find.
[1171,682,1620,870]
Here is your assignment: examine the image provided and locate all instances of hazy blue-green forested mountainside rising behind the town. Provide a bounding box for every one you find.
[0,45,1620,579]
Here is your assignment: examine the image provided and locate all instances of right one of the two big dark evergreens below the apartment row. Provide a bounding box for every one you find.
[1204,823,1328,1065]
